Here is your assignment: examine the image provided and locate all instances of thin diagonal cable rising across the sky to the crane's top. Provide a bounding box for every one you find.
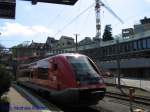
[54,3,95,37]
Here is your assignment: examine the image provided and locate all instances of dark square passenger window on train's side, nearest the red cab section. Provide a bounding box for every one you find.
[38,68,48,79]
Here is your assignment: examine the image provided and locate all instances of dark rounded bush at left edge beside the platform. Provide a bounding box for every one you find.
[0,65,12,98]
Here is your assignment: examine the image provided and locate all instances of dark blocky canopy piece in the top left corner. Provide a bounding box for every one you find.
[0,0,16,19]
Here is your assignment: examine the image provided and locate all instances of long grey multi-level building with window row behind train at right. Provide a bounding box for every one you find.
[58,17,150,79]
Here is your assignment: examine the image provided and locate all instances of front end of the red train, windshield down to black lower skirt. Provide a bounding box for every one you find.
[56,54,106,106]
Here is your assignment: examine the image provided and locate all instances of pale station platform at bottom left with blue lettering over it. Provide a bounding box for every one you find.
[7,87,51,112]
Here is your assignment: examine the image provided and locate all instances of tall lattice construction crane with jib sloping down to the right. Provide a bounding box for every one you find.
[95,0,123,40]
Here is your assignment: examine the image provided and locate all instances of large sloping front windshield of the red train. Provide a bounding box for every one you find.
[67,56,100,84]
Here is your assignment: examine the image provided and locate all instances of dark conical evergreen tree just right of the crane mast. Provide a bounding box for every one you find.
[102,25,114,41]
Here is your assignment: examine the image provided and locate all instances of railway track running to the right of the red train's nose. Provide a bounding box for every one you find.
[106,92,150,106]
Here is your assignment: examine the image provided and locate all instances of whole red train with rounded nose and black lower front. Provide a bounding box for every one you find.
[17,53,106,105]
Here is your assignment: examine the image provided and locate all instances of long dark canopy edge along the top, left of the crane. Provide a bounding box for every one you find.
[24,0,78,5]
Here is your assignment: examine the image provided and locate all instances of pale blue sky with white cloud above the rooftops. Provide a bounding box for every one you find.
[0,0,150,47]
